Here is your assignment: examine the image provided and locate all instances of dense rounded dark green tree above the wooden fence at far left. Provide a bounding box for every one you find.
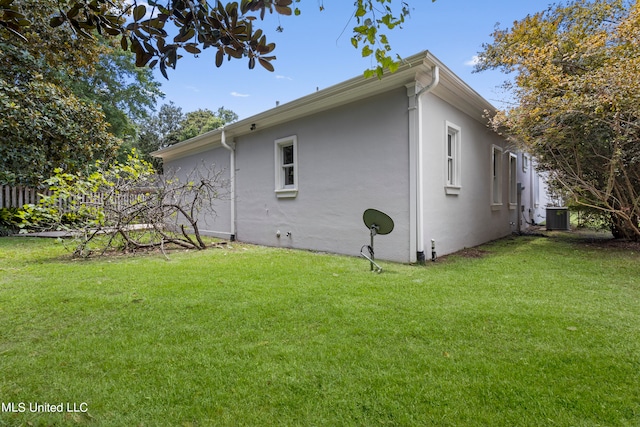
[0,44,119,186]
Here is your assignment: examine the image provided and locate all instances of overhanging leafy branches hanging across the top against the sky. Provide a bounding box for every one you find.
[0,0,424,77]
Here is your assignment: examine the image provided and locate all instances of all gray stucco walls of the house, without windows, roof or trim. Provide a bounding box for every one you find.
[159,81,524,262]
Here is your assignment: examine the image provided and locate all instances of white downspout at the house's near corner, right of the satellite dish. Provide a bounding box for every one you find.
[409,65,440,263]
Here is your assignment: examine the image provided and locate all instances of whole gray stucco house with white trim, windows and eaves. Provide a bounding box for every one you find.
[154,52,545,262]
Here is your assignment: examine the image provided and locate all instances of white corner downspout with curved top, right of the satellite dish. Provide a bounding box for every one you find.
[411,65,440,264]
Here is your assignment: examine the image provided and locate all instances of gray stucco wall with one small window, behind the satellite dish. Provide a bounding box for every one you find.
[235,88,409,262]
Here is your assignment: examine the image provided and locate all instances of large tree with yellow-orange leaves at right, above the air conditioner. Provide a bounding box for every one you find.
[478,0,640,240]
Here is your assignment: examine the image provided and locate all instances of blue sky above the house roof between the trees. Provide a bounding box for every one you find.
[152,0,550,119]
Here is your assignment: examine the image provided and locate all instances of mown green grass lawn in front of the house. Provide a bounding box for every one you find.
[0,234,640,426]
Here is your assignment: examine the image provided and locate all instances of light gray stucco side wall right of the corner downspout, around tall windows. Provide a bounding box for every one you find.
[422,94,515,259]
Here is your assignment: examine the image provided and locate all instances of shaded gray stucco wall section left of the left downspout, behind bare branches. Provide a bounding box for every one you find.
[164,147,231,238]
